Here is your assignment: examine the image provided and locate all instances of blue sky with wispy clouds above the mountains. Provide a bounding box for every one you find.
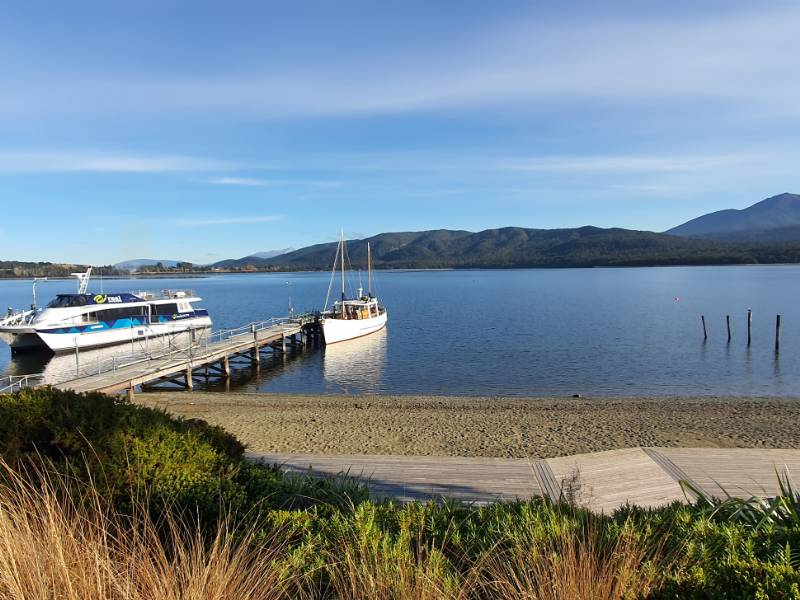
[0,0,800,264]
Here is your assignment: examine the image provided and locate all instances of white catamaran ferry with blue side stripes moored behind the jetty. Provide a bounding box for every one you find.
[0,268,212,353]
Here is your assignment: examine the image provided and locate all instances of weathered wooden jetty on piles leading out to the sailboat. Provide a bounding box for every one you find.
[55,315,320,397]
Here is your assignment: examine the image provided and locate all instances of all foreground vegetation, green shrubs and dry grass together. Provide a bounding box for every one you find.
[0,389,800,600]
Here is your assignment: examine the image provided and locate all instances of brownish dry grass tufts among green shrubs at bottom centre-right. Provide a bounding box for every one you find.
[326,507,672,600]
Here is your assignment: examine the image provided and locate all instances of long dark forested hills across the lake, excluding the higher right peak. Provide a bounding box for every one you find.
[212,227,800,271]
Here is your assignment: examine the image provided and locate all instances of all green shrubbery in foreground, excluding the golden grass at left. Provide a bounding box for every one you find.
[7,388,800,600]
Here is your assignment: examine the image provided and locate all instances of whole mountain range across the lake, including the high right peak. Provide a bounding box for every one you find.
[103,193,800,271]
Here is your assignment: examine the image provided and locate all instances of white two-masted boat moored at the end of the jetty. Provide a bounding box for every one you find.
[321,231,387,344]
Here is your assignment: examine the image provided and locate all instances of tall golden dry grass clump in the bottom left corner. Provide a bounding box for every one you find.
[0,461,296,600]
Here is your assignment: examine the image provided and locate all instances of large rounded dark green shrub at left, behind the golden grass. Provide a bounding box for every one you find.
[0,388,366,521]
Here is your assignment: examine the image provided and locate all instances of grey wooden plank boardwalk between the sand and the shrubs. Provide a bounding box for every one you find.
[253,448,800,512]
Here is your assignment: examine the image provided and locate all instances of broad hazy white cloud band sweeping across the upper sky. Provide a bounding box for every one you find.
[0,3,800,116]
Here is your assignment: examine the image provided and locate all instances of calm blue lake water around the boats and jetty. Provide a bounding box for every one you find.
[0,266,800,396]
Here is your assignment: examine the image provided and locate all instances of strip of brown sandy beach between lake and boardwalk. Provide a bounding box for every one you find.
[136,392,800,458]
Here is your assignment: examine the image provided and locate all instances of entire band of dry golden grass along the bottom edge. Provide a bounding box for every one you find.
[0,459,668,600]
